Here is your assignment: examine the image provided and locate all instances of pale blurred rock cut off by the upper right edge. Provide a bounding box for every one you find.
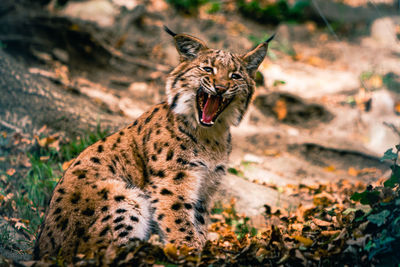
[371,17,399,46]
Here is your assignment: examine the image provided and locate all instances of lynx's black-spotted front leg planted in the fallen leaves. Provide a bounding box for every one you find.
[152,176,206,248]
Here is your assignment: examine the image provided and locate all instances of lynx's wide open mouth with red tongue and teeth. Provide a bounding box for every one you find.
[196,88,233,127]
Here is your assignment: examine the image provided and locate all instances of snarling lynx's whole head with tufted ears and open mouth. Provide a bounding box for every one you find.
[165,27,273,128]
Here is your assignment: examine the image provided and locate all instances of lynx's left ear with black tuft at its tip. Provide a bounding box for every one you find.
[164,26,207,60]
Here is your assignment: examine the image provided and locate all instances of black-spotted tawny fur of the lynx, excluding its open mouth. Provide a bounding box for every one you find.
[35,27,268,259]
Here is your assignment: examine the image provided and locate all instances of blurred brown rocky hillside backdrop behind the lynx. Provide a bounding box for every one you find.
[0,0,400,264]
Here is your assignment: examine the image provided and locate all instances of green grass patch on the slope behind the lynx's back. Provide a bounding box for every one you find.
[0,126,108,242]
